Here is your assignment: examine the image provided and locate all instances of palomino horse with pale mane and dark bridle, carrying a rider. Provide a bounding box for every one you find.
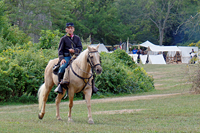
[38,45,102,124]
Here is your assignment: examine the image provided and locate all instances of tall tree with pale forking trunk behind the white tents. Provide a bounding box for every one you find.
[144,0,181,45]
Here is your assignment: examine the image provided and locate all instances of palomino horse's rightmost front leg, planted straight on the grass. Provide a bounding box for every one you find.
[84,88,94,124]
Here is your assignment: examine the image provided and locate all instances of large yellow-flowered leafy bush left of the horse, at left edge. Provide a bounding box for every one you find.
[0,43,57,101]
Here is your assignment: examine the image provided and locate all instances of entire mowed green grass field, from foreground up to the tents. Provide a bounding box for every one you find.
[0,64,200,133]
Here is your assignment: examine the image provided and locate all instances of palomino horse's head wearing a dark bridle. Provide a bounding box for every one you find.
[87,45,102,74]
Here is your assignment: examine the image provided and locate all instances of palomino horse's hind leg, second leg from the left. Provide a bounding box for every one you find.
[56,89,66,120]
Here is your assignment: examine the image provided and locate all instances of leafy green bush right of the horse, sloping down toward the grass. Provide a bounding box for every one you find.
[96,49,154,94]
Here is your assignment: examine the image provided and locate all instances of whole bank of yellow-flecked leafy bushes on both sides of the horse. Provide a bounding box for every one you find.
[0,42,154,103]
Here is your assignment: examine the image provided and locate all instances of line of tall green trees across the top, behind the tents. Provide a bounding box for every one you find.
[3,0,200,45]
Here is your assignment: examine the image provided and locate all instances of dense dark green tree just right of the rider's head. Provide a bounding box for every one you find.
[69,0,128,45]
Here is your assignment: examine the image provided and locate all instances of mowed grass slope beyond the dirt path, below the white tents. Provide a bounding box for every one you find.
[140,64,193,94]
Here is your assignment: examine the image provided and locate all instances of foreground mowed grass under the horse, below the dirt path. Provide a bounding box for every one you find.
[0,94,200,133]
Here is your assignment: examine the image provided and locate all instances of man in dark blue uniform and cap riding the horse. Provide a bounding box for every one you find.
[54,23,98,94]
